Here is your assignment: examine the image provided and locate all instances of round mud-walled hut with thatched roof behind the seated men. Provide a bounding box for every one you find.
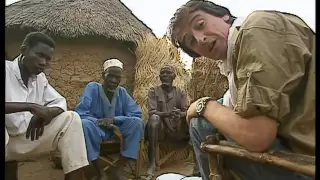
[5,0,154,109]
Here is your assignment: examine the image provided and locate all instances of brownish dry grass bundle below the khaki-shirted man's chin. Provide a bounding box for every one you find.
[188,57,228,101]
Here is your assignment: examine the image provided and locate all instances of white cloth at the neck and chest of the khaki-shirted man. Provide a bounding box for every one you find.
[218,18,245,108]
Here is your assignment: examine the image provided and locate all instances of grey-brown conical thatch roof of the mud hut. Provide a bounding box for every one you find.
[5,0,152,42]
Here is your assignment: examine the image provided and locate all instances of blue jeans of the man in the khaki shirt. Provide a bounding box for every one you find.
[190,118,312,180]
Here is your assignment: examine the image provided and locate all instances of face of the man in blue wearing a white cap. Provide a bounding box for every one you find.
[103,67,122,92]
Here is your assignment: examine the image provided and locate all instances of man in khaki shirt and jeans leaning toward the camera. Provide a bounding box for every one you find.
[169,0,315,180]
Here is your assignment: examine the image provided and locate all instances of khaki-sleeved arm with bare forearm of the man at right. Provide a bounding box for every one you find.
[204,25,311,151]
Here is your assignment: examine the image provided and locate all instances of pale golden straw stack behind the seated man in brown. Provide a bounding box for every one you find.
[133,36,191,166]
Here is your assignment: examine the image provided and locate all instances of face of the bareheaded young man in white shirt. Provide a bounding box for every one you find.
[21,43,54,75]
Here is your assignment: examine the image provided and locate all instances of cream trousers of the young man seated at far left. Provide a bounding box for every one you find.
[6,111,89,174]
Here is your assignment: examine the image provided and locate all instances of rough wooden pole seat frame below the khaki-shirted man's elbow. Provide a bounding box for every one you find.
[201,135,316,180]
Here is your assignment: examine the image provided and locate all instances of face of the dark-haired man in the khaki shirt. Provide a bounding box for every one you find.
[176,10,231,60]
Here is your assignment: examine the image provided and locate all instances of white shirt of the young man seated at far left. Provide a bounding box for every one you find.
[5,56,67,136]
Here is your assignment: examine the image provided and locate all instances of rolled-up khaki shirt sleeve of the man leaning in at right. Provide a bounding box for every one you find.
[233,28,312,123]
